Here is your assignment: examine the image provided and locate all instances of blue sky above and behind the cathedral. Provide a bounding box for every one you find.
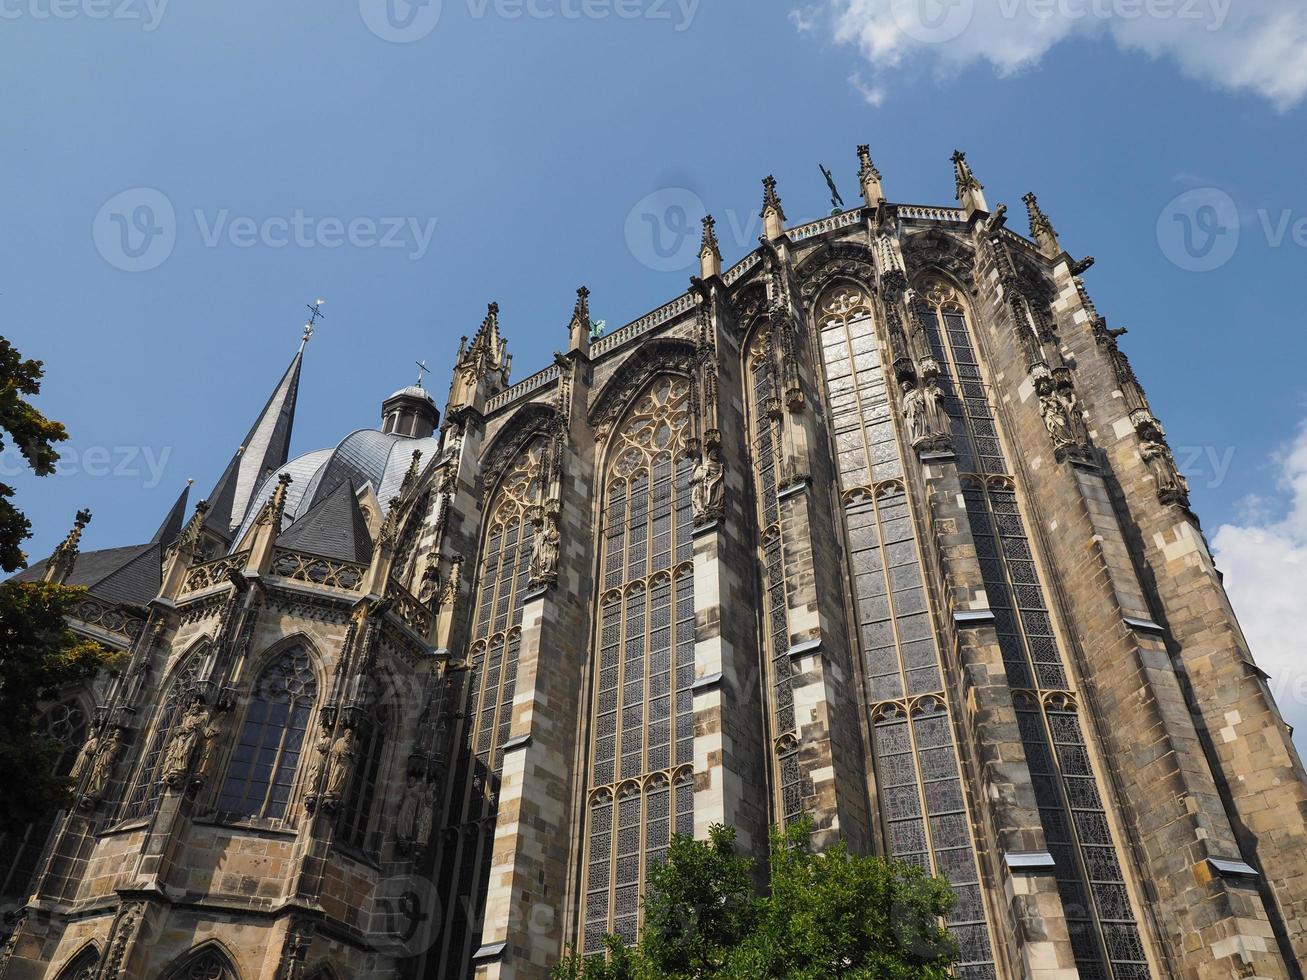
[0,0,1307,721]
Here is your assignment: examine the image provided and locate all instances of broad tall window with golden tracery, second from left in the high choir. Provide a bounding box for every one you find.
[582,376,694,953]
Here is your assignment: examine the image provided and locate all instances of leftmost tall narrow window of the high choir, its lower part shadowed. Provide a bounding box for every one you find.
[434,438,546,977]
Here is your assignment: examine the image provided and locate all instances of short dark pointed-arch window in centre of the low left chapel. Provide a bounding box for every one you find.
[218,644,318,819]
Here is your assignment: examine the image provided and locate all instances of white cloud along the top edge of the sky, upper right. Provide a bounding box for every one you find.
[791,0,1307,110]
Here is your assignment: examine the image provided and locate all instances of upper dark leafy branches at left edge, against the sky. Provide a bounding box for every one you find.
[0,337,68,572]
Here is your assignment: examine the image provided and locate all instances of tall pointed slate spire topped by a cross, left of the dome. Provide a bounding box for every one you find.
[204,345,305,541]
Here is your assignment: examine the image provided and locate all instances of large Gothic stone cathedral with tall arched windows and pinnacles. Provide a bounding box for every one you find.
[0,148,1307,980]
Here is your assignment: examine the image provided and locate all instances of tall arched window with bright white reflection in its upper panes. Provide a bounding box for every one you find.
[818,285,995,980]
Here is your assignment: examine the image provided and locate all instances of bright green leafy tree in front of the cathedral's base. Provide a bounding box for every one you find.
[554,821,955,980]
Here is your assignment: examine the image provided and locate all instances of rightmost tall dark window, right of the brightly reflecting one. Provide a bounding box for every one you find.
[918,285,1149,980]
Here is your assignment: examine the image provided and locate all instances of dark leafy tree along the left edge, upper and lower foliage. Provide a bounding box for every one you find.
[0,337,115,834]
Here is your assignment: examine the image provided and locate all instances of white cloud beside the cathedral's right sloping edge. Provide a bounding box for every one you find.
[1212,425,1307,745]
